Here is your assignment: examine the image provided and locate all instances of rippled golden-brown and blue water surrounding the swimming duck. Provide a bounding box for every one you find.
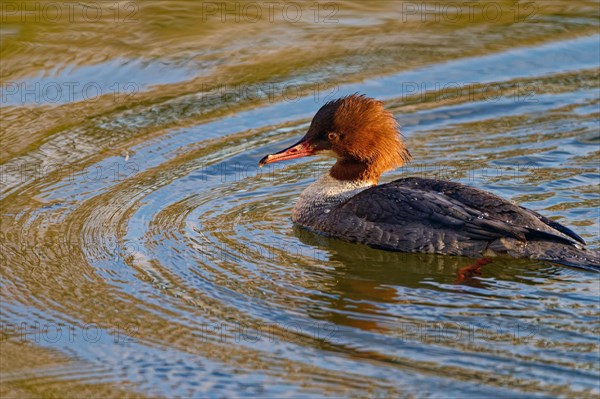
[0,1,600,397]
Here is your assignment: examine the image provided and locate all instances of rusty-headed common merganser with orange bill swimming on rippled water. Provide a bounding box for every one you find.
[259,94,600,270]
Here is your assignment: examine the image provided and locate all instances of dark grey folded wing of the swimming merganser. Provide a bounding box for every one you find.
[319,178,584,255]
